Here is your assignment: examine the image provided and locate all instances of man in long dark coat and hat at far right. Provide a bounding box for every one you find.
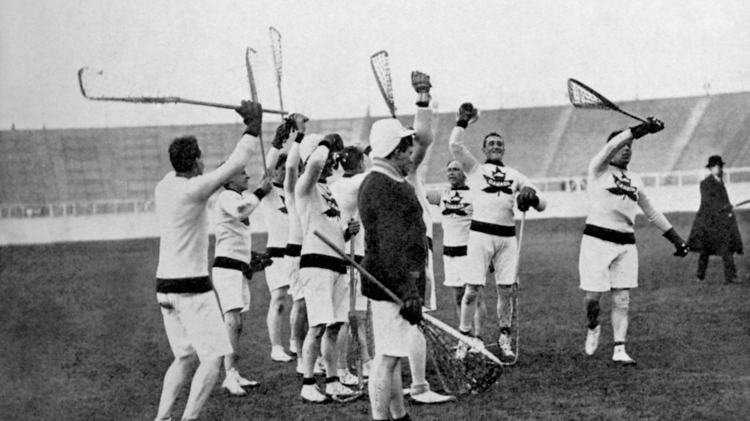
[688,155,742,284]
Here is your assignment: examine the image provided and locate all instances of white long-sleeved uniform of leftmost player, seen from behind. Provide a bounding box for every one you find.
[154,135,256,360]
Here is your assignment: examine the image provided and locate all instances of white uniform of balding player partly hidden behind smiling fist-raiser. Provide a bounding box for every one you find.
[427,187,474,287]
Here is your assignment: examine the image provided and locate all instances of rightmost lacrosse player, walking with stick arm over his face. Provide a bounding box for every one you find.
[578,117,688,365]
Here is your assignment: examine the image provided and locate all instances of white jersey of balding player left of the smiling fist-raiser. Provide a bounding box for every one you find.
[428,187,474,247]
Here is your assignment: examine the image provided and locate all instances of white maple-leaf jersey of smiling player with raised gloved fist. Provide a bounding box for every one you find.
[450,127,546,227]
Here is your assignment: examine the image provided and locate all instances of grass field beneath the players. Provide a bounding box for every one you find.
[0,211,750,420]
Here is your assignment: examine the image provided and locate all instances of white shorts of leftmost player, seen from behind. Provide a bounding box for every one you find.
[156,291,234,361]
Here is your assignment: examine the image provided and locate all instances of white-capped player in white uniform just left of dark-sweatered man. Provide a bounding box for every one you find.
[294,134,359,403]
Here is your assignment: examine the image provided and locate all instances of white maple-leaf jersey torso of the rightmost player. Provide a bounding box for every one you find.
[586,165,671,233]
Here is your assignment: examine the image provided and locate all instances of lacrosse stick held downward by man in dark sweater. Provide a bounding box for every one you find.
[314,230,502,394]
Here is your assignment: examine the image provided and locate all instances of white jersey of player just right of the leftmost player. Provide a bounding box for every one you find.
[214,190,260,263]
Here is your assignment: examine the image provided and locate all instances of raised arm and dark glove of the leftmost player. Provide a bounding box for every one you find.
[191,101,263,200]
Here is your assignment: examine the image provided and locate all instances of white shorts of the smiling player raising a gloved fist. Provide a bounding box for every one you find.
[464,231,518,285]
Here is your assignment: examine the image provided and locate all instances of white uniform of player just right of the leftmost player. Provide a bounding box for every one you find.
[211,190,260,313]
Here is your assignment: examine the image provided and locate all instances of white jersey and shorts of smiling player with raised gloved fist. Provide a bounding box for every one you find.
[450,127,545,285]
